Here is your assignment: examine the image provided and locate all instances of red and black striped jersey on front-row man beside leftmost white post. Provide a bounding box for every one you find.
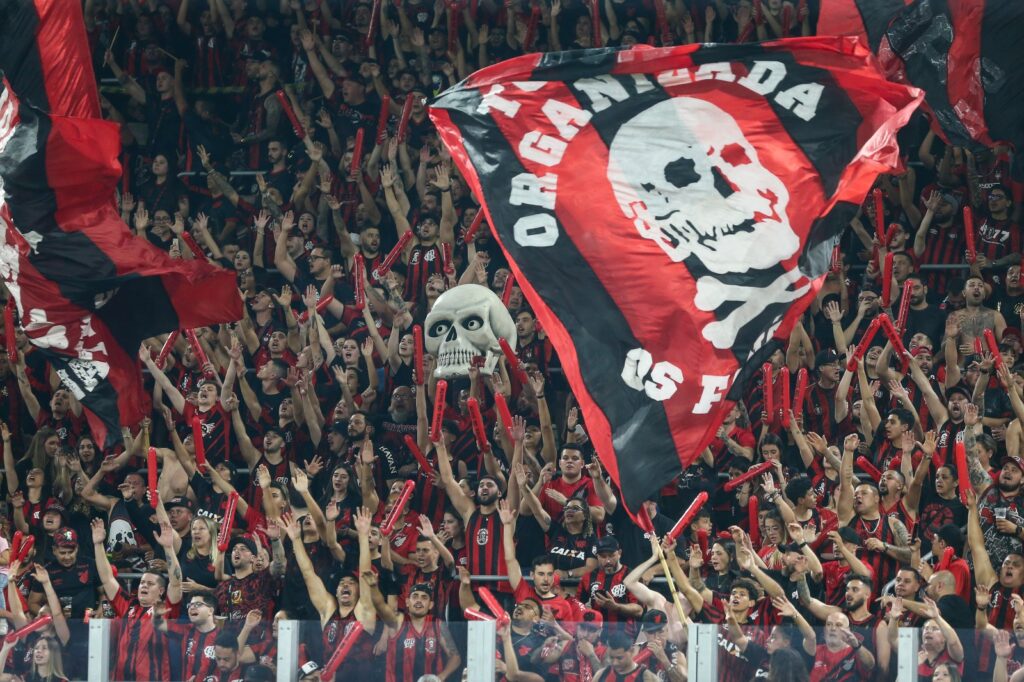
[111,588,180,680]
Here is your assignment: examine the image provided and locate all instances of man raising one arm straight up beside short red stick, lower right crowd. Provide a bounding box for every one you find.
[837,436,910,589]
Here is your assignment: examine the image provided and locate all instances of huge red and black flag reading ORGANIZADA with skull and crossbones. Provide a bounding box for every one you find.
[430,38,921,511]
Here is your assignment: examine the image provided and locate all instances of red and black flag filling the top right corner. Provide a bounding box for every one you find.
[880,0,1024,161]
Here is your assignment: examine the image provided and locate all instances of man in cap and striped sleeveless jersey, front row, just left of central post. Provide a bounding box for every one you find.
[366,573,462,682]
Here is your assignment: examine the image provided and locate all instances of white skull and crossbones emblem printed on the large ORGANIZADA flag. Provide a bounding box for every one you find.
[608,97,808,348]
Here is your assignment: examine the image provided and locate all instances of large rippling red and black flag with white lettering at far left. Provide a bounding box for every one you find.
[0,0,242,445]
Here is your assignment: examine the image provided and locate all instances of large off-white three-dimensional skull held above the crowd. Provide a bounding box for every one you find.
[423,285,516,379]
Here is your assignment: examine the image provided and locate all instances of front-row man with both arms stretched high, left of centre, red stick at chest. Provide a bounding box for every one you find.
[281,507,379,680]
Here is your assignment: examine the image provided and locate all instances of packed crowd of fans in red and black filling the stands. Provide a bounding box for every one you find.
[0,0,1024,682]
